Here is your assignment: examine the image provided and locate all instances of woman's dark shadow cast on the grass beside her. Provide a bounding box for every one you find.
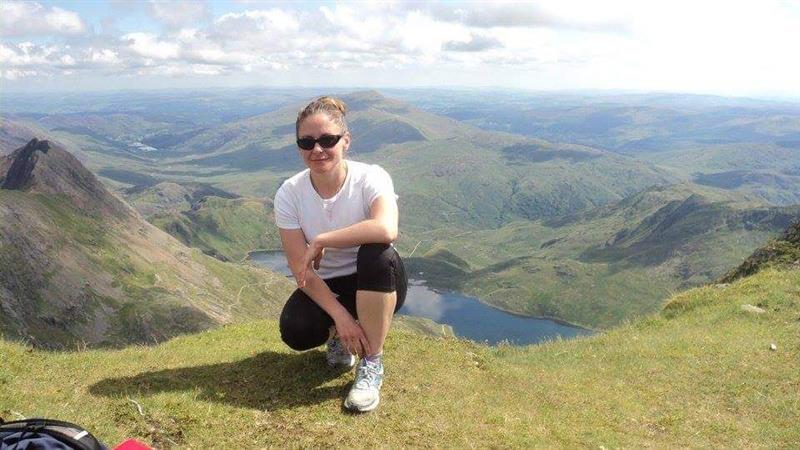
[89,351,351,411]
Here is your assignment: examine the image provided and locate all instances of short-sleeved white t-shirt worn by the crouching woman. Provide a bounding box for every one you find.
[275,160,397,279]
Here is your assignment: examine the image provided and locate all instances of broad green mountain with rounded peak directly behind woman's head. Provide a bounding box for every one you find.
[161,91,675,231]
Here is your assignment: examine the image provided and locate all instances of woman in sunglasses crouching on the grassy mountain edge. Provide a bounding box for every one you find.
[275,97,408,412]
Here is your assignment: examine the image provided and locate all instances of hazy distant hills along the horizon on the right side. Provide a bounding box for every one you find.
[391,90,800,206]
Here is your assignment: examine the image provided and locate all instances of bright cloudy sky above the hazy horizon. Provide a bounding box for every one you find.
[0,0,800,99]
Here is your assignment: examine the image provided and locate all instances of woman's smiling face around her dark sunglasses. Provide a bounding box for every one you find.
[298,113,350,174]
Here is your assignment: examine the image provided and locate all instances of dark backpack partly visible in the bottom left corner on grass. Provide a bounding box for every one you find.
[0,419,108,450]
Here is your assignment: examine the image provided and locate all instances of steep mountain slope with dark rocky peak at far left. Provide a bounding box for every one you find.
[0,139,291,348]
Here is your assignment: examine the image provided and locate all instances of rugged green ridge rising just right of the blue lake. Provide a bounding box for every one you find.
[400,184,800,328]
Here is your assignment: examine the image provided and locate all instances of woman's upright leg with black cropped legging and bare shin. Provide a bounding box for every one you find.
[356,244,407,355]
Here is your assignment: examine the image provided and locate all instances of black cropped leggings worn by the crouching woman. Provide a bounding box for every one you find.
[280,244,408,350]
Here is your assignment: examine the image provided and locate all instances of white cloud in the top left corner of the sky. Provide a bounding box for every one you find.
[0,1,87,37]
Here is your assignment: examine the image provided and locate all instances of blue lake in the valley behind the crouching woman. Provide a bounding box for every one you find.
[250,251,592,345]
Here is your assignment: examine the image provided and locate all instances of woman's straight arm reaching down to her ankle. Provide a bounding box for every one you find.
[278,228,370,355]
